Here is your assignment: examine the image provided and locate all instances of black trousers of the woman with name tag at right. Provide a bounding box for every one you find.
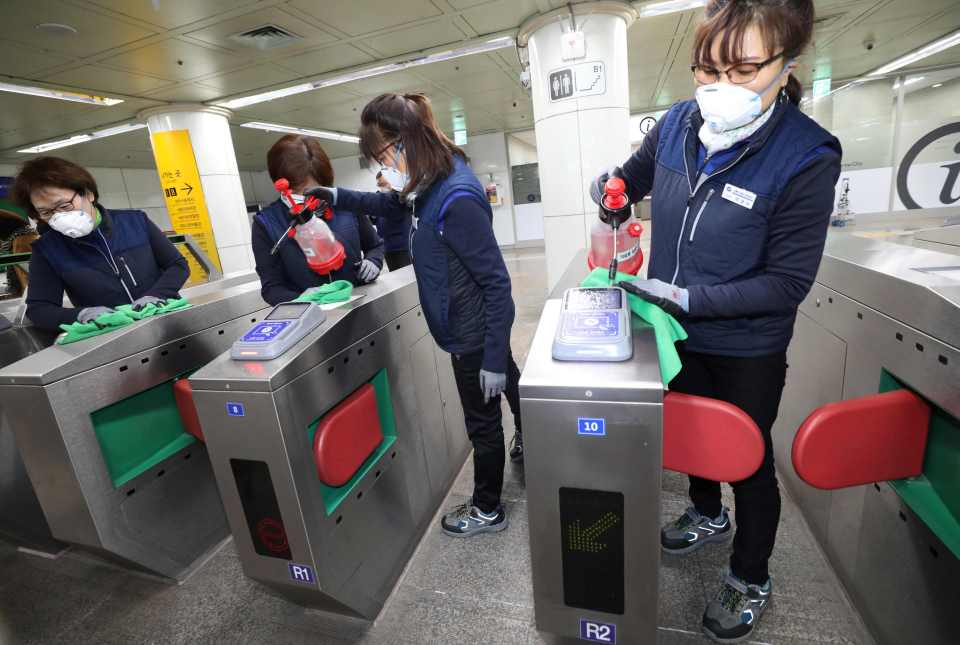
[670,349,787,585]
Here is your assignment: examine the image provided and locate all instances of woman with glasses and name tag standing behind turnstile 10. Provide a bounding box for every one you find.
[591,0,841,642]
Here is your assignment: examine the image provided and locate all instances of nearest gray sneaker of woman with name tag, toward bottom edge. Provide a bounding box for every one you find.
[703,573,773,643]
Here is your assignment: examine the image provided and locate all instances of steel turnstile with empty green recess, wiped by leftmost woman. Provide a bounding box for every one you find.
[0,273,267,579]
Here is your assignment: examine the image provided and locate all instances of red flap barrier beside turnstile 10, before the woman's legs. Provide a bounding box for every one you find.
[663,392,764,482]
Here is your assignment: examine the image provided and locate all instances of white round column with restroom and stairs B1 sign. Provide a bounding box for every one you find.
[518,1,636,289]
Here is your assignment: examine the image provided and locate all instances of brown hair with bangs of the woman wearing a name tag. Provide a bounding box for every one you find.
[693,0,814,104]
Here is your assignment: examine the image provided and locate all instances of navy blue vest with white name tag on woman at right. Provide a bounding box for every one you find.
[648,101,839,356]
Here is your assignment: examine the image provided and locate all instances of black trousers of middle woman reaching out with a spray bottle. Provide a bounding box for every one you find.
[451,350,520,513]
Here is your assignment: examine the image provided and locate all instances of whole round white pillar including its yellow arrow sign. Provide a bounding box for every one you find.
[139,104,254,274]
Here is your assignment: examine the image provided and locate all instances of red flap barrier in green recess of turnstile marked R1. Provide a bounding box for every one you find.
[313,383,383,488]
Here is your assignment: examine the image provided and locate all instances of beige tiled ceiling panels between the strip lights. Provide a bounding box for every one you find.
[0,0,960,169]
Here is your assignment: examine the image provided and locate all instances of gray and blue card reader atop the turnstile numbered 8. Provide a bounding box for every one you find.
[230,302,327,361]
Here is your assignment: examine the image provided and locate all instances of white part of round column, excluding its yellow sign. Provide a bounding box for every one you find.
[140,104,254,274]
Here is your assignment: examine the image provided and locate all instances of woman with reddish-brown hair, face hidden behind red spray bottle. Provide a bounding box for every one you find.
[252,134,383,305]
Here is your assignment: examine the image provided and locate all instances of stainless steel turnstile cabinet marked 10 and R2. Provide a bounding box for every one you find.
[520,249,663,645]
